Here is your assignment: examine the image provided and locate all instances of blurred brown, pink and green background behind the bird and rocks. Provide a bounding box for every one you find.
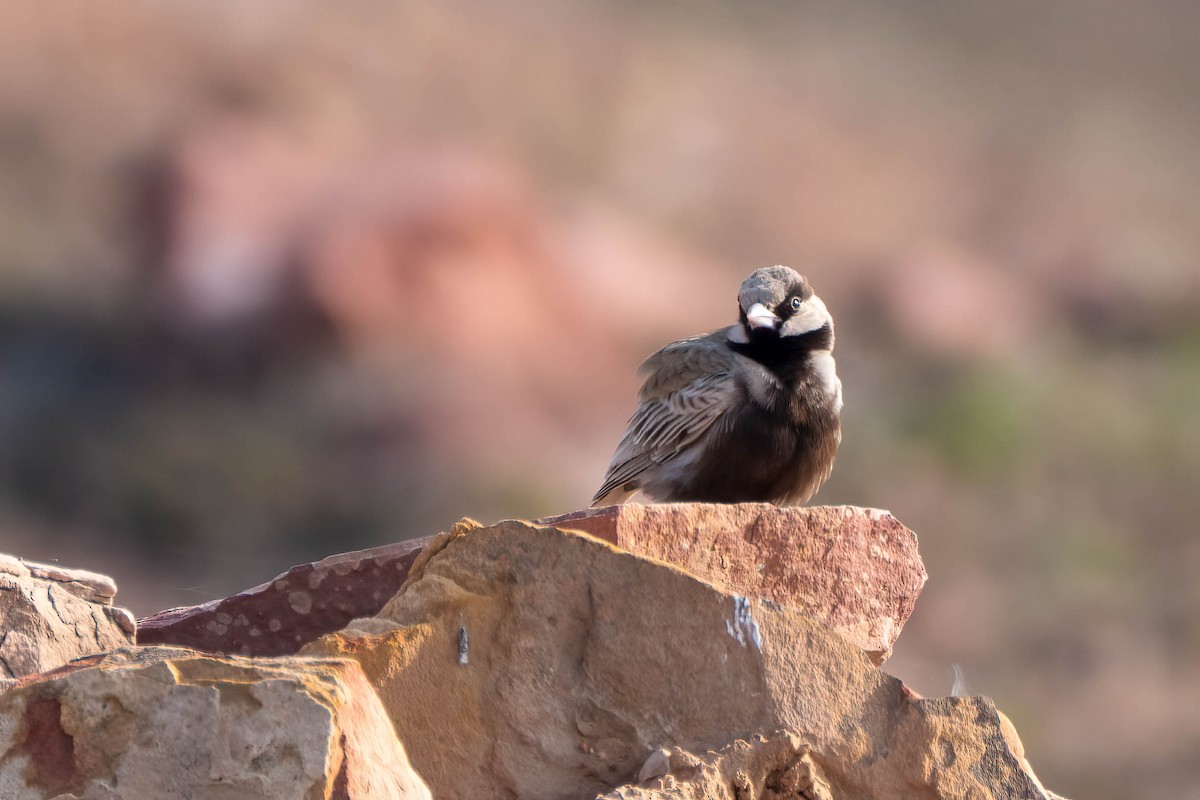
[0,0,1200,799]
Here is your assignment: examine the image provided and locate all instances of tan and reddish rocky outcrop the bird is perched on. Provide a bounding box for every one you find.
[0,504,1070,800]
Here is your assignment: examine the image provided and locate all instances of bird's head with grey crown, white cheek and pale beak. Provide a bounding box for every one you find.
[730,266,833,343]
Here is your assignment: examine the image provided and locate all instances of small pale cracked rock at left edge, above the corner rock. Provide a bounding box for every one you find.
[0,554,134,688]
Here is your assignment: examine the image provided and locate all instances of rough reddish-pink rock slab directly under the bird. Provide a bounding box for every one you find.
[539,503,928,663]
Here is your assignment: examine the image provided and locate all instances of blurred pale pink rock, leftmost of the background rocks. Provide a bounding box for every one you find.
[148,113,344,333]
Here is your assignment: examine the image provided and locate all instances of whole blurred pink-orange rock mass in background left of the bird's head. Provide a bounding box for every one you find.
[152,130,734,355]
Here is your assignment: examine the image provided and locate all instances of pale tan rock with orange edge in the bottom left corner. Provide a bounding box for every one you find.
[0,648,430,800]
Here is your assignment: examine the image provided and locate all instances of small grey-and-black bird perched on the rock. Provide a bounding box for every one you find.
[592,266,841,507]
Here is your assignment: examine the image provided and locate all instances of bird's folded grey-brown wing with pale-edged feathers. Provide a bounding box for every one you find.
[592,331,738,505]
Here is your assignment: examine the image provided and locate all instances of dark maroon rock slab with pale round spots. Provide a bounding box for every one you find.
[138,539,428,656]
